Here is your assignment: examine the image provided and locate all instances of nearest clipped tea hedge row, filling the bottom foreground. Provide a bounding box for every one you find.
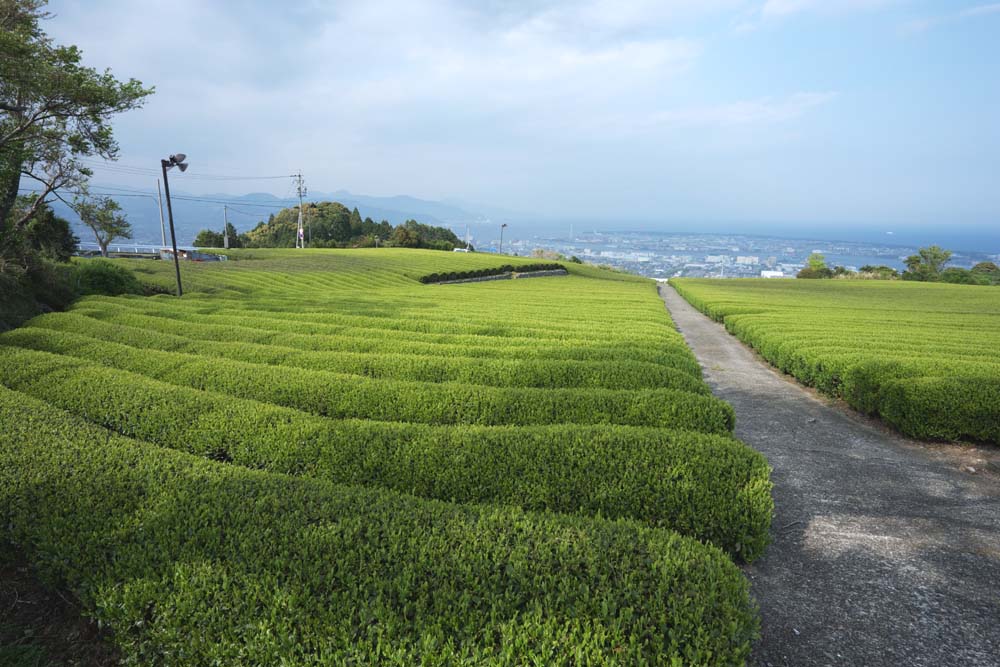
[0,390,757,667]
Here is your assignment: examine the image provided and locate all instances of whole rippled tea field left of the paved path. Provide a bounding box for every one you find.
[0,249,773,666]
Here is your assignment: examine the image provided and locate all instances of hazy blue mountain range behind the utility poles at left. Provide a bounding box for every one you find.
[52,190,508,246]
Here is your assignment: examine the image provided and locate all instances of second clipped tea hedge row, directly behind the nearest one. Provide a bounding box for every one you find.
[0,348,772,560]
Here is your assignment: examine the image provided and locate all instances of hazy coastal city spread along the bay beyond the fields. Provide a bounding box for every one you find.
[483,232,1000,278]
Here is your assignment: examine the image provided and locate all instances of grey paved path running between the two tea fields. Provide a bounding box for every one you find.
[660,286,1000,667]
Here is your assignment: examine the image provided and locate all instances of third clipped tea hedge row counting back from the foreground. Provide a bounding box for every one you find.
[0,329,735,433]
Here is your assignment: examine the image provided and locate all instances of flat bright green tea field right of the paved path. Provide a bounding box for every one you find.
[670,279,1000,443]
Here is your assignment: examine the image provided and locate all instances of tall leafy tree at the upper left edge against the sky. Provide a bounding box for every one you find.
[0,0,153,240]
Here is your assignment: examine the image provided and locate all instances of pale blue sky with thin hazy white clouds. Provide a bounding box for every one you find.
[45,0,1000,233]
